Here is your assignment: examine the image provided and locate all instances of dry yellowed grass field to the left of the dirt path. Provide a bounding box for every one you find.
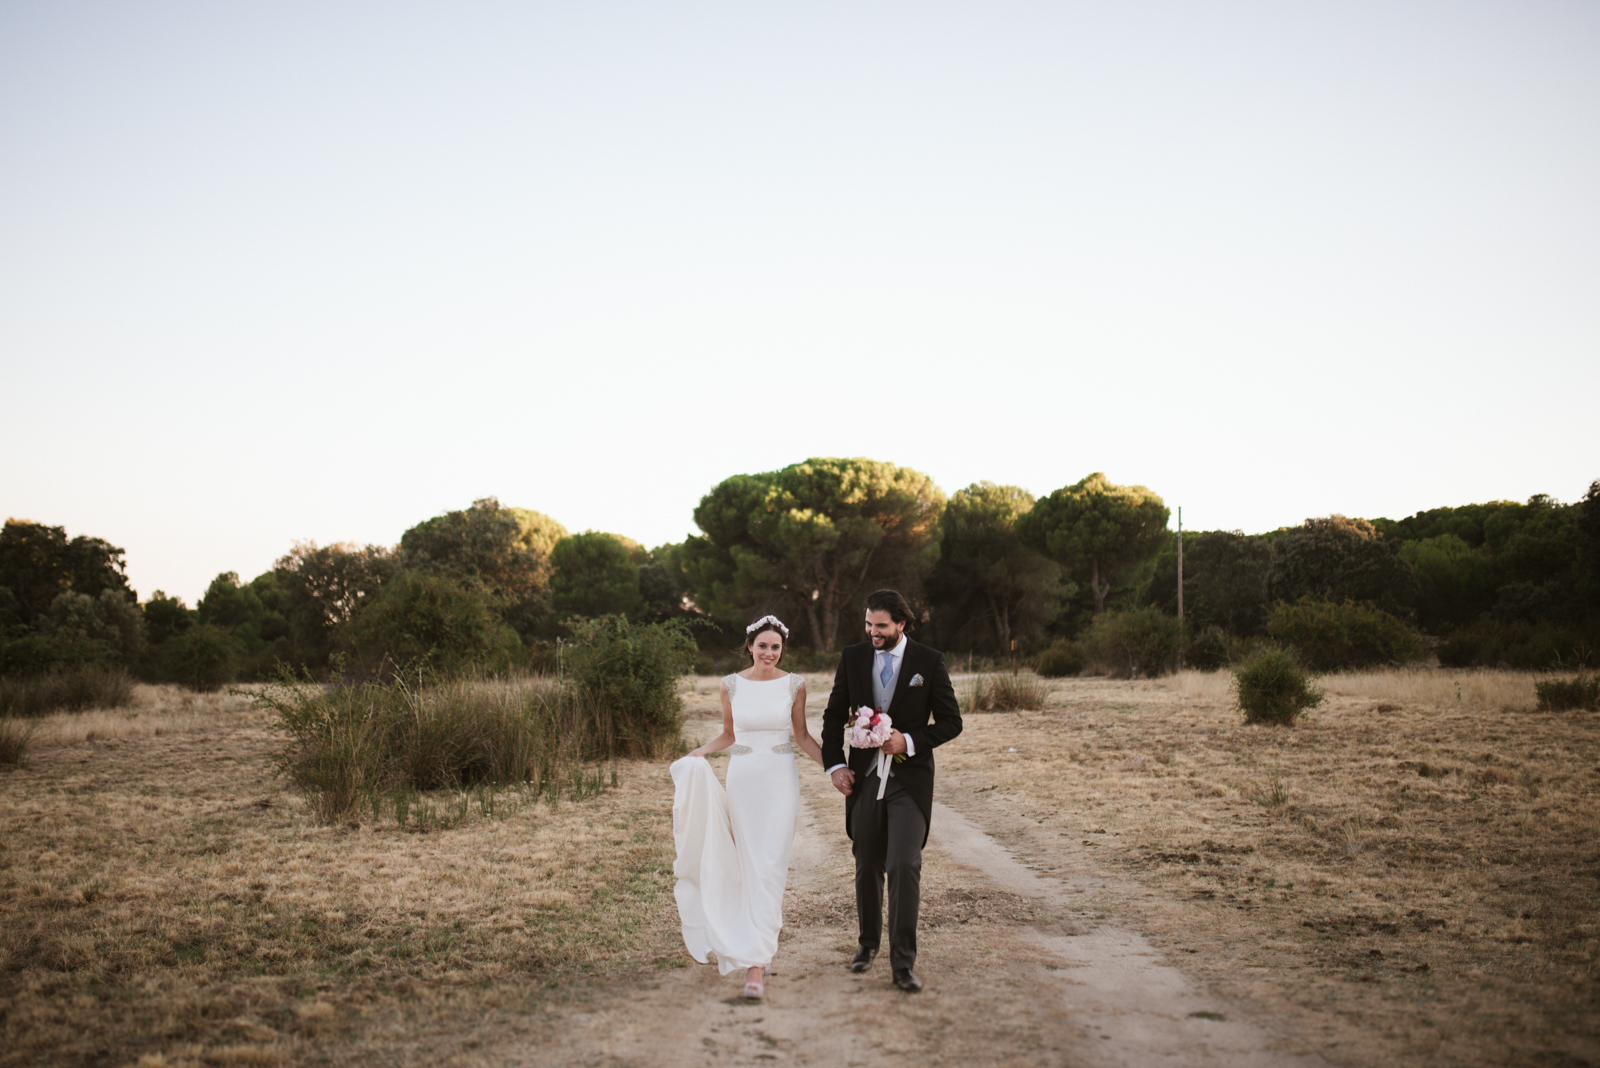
[0,687,677,1068]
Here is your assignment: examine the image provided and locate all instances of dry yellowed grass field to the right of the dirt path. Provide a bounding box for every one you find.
[939,670,1600,1065]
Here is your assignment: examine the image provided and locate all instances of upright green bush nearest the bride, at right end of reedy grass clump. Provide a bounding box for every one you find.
[566,616,696,756]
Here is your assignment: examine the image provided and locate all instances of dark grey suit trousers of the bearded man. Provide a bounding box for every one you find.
[850,775,928,969]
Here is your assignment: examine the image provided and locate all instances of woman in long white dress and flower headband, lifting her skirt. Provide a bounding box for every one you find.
[672,616,822,998]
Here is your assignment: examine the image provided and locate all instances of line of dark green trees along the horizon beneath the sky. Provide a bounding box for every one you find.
[0,459,1600,686]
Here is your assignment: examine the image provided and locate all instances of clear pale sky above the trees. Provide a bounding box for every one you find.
[0,0,1600,603]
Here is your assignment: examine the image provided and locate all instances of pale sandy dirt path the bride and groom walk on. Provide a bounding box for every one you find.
[524,723,1325,1068]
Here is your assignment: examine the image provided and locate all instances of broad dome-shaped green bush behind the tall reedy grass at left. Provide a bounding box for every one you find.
[346,571,526,678]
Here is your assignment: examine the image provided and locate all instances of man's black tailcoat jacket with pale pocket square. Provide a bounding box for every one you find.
[822,638,962,844]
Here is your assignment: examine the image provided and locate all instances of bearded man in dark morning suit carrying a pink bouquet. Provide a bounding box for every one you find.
[822,590,962,993]
